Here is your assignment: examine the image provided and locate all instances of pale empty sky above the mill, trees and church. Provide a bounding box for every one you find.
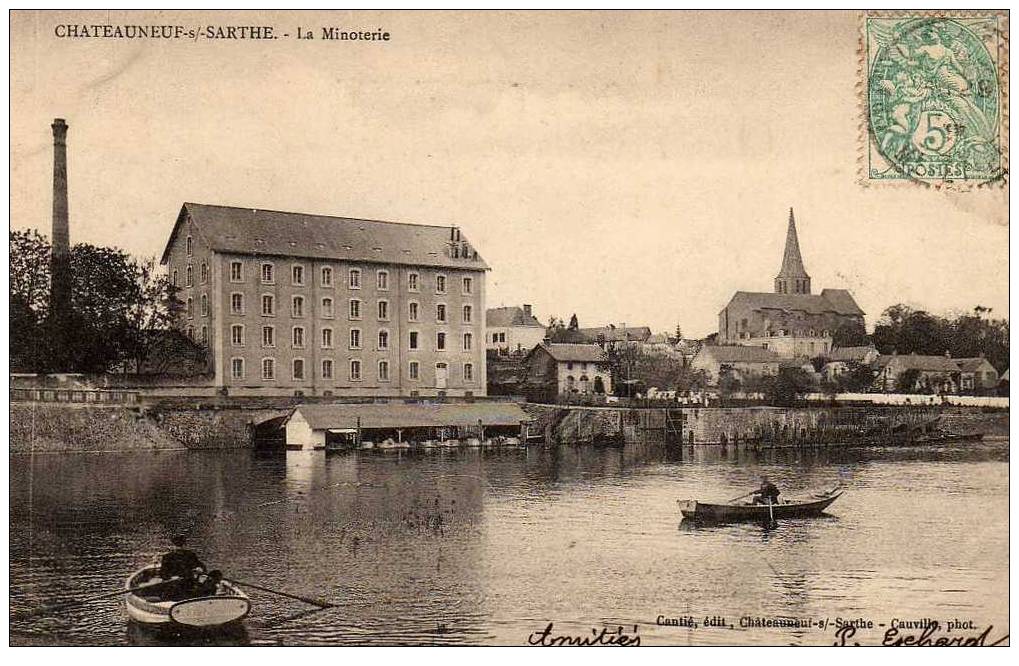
[11,11,1008,336]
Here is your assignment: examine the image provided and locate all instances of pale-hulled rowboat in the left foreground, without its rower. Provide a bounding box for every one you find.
[125,566,251,630]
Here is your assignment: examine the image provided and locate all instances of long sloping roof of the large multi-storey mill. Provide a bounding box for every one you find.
[162,203,488,271]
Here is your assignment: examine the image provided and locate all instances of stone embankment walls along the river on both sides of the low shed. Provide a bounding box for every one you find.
[9,402,1009,454]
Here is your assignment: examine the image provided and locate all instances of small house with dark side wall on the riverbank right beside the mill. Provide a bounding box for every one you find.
[525,342,612,401]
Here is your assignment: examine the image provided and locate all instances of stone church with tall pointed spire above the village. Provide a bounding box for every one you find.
[718,209,864,358]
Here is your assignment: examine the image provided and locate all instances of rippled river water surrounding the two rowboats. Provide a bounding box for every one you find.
[10,440,1009,645]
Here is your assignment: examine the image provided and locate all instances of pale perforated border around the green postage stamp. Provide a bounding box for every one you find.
[856,10,1009,191]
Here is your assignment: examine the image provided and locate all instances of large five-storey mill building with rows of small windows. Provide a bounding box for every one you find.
[161,204,489,396]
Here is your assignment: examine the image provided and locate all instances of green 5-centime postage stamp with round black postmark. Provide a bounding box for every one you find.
[861,12,1008,186]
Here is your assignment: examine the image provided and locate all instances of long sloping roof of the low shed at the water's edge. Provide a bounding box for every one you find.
[293,402,531,430]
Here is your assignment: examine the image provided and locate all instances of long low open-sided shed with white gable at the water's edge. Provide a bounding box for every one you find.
[284,402,532,450]
